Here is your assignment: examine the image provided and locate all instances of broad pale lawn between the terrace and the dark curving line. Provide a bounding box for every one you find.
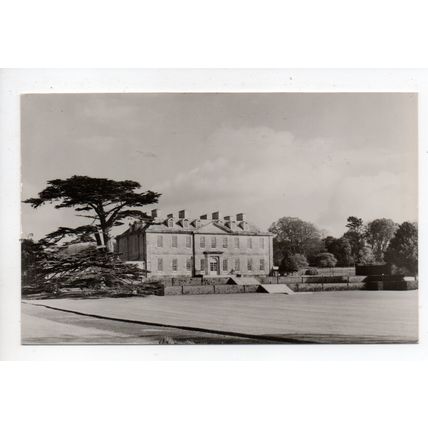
[23,290,418,343]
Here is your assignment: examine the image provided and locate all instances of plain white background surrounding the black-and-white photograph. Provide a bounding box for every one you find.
[0,0,428,427]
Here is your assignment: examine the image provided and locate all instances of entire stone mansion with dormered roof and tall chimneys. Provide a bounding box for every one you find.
[116,210,273,277]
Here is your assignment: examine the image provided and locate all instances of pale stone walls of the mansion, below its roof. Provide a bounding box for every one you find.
[118,232,272,276]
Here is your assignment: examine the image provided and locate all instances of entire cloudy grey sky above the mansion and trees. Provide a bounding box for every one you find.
[21,93,417,239]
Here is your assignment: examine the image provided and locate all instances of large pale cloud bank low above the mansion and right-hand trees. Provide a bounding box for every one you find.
[150,127,416,234]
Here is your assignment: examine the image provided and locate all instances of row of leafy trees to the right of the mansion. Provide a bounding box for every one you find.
[269,216,418,274]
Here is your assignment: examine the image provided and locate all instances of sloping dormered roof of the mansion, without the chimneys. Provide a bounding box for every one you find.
[118,219,272,237]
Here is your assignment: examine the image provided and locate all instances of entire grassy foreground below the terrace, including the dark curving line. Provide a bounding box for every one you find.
[22,291,418,344]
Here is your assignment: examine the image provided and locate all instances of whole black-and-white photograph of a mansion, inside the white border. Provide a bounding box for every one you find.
[20,92,419,345]
